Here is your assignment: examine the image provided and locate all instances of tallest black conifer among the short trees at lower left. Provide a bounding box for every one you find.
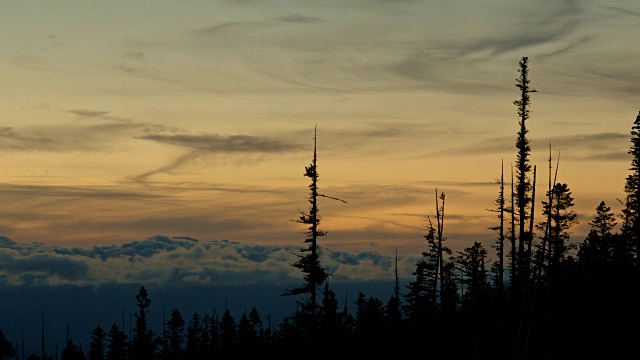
[131,286,156,360]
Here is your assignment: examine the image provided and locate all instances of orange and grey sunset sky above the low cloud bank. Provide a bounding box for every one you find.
[0,0,640,255]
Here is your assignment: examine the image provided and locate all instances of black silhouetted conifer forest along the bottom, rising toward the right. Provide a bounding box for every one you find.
[0,57,640,360]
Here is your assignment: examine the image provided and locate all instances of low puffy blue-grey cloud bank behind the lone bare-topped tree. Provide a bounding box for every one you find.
[0,235,415,286]
